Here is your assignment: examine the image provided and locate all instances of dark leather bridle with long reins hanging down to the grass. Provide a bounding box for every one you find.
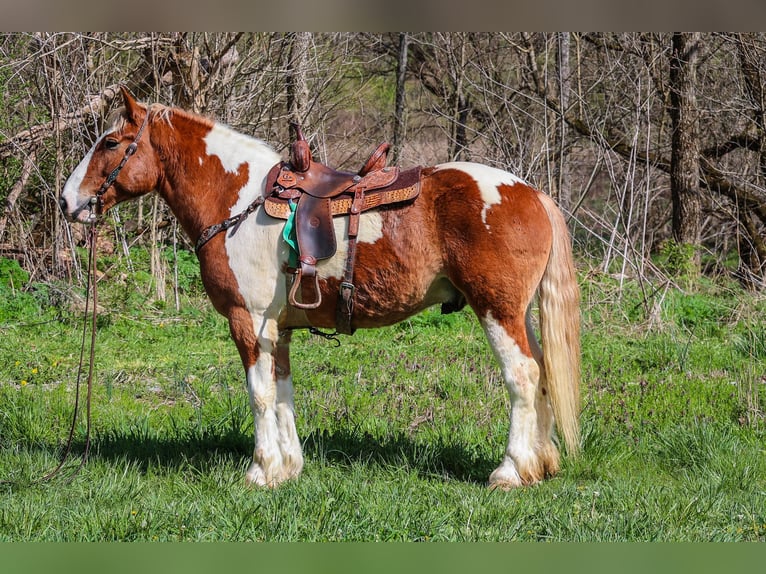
[27,106,151,483]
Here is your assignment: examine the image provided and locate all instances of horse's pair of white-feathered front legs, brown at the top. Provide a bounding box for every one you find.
[229,309,303,487]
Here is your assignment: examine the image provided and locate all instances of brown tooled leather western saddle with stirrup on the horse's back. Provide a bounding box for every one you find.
[264,126,421,334]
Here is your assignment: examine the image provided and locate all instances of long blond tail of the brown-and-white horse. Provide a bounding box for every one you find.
[538,193,580,455]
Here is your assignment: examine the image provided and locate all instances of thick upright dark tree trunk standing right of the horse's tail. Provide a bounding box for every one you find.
[669,32,701,277]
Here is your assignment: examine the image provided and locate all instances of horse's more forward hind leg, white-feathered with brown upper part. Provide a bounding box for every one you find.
[481,312,550,488]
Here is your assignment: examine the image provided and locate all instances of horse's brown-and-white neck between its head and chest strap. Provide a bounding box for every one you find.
[160,117,280,239]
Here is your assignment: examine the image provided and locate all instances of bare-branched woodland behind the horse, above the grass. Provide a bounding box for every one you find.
[0,32,766,292]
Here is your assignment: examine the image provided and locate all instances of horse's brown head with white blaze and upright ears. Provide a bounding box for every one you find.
[59,88,162,223]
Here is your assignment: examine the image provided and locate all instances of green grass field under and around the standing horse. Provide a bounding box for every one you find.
[0,258,766,541]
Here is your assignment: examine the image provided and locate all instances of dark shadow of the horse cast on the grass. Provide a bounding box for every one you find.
[81,430,493,483]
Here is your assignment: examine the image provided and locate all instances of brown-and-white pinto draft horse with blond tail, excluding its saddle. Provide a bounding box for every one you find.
[60,88,580,490]
